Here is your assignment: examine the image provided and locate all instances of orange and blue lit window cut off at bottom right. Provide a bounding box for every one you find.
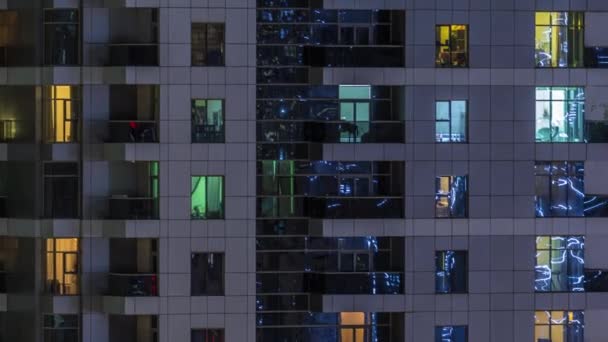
[534,311,585,342]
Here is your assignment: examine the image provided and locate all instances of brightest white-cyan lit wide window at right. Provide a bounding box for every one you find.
[535,87,585,143]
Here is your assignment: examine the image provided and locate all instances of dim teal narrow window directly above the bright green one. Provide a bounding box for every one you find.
[192,99,225,143]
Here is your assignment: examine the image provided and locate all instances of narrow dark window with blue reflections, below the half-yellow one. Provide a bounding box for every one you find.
[435,251,468,293]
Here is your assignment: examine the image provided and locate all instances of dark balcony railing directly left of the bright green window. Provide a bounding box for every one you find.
[109,195,158,220]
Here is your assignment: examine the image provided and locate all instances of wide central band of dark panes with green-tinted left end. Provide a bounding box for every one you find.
[257,160,404,218]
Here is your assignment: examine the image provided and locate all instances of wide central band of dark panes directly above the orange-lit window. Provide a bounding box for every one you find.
[256,236,404,296]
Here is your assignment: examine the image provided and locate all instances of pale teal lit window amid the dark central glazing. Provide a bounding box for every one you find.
[339,85,371,142]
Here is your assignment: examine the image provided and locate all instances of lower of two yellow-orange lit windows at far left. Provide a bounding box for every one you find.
[45,238,79,295]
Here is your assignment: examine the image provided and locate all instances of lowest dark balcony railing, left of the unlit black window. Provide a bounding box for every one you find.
[108,273,158,297]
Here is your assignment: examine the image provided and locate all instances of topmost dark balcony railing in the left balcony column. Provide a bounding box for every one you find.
[109,43,158,66]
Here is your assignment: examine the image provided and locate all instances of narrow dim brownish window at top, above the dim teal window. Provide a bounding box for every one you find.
[191,23,224,66]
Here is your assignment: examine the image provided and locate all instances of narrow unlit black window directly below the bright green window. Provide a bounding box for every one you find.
[190,253,224,296]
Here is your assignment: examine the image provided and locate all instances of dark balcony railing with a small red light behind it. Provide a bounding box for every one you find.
[105,120,158,143]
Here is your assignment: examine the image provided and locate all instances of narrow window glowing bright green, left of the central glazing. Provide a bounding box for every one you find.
[190,176,224,219]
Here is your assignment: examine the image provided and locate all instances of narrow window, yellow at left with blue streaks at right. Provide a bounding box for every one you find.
[435,176,468,218]
